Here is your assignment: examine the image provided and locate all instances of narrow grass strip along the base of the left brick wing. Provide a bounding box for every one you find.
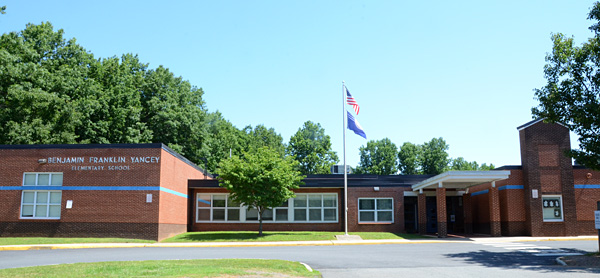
[0,237,156,245]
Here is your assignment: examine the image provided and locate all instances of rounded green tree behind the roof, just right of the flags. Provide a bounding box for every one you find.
[355,138,398,175]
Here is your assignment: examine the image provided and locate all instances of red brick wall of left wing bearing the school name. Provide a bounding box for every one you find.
[0,145,202,239]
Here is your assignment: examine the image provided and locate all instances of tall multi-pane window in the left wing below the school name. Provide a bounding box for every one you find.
[21,173,63,219]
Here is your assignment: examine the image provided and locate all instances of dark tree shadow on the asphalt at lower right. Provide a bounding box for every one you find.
[445,248,600,273]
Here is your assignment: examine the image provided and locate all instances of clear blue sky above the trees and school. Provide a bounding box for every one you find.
[0,0,594,166]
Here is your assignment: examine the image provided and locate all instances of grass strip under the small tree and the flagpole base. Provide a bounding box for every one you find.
[163,231,424,242]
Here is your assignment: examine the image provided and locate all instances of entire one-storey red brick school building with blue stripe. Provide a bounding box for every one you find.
[0,120,600,240]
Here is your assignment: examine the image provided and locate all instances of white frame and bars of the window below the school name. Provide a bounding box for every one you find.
[19,172,64,220]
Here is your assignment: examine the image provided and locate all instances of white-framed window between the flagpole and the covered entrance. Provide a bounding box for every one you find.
[358,198,394,223]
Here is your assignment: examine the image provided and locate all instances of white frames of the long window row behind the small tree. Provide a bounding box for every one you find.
[195,192,339,224]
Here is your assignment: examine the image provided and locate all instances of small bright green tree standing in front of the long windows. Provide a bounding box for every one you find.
[217,147,304,236]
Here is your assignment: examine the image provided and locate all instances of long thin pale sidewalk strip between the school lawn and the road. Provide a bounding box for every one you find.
[0,236,598,251]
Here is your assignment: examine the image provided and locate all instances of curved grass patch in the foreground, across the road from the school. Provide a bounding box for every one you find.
[0,259,321,278]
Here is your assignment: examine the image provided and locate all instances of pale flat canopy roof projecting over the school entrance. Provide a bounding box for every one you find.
[412,171,510,191]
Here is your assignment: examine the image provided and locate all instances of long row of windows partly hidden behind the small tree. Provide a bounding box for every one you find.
[196,193,338,222]
